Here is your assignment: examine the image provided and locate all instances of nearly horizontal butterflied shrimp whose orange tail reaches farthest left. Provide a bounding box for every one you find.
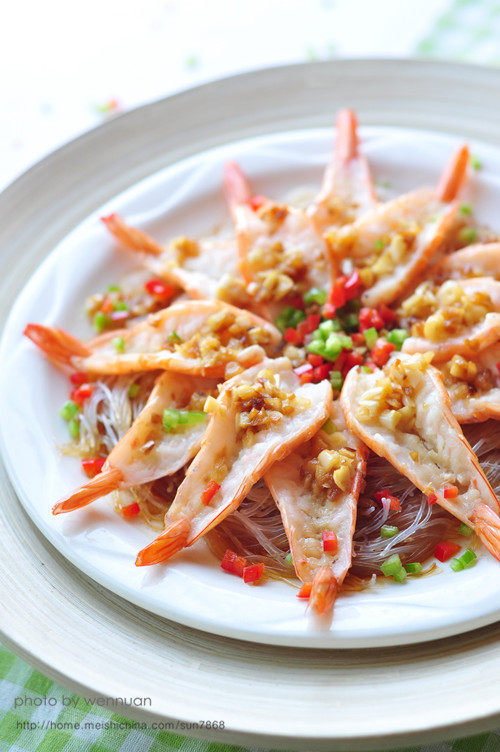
[24,300,281,378]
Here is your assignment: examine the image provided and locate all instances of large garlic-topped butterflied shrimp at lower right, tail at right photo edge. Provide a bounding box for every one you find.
[340,353,500,559]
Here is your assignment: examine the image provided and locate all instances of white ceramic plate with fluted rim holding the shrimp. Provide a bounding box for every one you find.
[0,122,500,647]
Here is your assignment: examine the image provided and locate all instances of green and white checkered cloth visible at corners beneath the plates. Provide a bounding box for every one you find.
[0,0,500,752]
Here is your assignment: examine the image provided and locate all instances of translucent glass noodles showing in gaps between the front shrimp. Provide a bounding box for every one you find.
[71,373,500,587]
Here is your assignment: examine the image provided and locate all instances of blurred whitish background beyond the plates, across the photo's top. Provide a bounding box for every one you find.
[0,0,500,187]
